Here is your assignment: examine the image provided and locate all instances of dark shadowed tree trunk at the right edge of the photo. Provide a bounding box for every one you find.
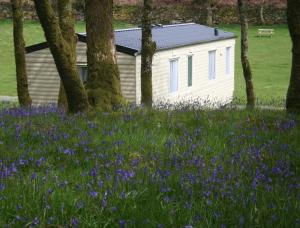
[286,0,300,113]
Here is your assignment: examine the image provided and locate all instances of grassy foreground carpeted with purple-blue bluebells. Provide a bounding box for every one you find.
[0,107,300,227]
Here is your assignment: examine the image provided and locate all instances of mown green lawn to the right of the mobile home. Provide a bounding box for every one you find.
[221,25,292,106]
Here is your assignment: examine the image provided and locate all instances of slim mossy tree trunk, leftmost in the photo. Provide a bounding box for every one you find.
[11,0,32,107]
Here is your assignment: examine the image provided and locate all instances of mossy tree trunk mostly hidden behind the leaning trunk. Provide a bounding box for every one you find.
[56,0,77,111]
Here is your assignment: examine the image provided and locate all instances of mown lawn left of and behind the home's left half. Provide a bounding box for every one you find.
[0,19,130,96]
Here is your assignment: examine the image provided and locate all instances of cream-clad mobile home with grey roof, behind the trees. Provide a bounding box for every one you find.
[26,23,236,104]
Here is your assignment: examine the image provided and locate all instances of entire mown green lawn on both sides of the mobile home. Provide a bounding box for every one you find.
[0,20,291,106]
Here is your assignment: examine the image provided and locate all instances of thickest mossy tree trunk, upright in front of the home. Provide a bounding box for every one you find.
[86,0,123,111]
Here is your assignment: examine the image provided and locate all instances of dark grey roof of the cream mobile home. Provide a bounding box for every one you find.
[26,23,236,55]
